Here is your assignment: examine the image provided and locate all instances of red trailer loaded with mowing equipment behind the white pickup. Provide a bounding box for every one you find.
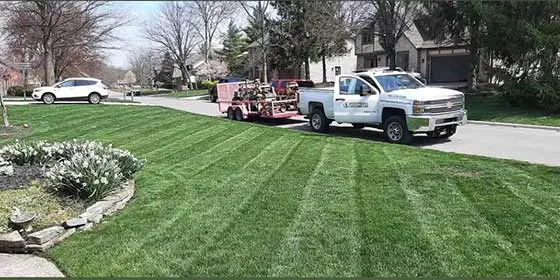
[217,82,299,121]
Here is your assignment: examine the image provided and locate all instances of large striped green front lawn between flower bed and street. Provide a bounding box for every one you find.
[0,105,560,277]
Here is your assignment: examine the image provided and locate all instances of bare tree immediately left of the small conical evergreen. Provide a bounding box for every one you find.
[184,0,238,62]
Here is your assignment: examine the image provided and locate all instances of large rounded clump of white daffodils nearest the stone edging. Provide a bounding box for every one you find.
[47,153,123,201]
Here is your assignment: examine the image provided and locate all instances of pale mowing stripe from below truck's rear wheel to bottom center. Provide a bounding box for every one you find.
[268,139,361,277]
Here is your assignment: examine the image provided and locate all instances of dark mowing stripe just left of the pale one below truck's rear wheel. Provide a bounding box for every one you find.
[184,138,326,276]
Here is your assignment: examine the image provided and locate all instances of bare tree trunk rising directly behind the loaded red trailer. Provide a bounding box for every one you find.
[239,1,270,83]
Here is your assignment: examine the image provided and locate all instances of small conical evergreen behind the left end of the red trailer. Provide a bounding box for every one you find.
[221,21,247,76]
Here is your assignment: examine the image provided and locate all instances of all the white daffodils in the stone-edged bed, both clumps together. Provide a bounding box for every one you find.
[0,140,144,200]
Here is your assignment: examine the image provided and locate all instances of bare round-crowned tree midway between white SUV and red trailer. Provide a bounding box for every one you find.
[145,2,200,87]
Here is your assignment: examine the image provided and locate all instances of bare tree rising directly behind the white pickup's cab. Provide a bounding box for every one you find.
[369,0,422,69]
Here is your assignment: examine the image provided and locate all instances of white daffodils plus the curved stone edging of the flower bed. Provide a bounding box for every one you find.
[0,140,144,252]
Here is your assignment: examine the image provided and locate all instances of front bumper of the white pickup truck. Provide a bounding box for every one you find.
[406,110,467,132]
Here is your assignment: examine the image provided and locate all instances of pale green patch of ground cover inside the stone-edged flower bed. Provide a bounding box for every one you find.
[0,182,84,232]
